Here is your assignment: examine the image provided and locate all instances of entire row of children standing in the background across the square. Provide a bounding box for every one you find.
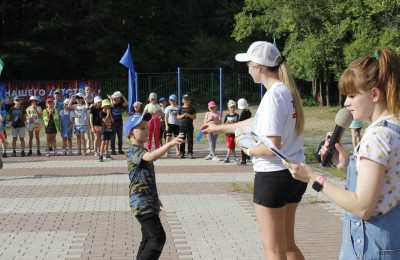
[0,86,251,165]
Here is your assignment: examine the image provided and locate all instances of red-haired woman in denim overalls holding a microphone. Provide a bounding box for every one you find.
[284,48,400,260]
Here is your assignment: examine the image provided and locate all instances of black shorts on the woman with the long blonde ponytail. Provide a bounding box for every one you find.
[253,169,307,208]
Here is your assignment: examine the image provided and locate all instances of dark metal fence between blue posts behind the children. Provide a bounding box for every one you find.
[102,73,261,109]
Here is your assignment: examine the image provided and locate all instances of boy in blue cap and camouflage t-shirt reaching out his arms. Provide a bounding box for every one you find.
[124,113,186,259]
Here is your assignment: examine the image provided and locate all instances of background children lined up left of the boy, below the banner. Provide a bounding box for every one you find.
[0,86,129,161]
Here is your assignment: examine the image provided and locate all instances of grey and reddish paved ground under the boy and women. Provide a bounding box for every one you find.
[0,145,343,260]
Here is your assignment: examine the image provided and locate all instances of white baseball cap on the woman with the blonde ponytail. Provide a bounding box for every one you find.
[235,41,281,67]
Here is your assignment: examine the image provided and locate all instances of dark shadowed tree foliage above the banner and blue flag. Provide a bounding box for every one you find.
[0,0,243,80]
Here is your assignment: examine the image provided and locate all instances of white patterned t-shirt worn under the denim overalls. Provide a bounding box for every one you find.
[354,116,400,217]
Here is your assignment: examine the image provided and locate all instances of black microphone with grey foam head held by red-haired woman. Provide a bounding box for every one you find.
[321,108,353,166]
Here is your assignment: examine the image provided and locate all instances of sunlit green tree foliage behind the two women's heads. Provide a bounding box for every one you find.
[233,0,400,104]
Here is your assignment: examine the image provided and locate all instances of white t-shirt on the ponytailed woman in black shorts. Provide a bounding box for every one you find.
[253,82,305,172]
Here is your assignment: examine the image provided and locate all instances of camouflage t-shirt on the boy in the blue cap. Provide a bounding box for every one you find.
[126,145,160,215]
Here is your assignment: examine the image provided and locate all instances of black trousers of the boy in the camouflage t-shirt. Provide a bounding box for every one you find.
[136,213,166,260]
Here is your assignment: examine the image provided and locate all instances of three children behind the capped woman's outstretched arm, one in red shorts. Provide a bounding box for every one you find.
[204,98,251,165]
